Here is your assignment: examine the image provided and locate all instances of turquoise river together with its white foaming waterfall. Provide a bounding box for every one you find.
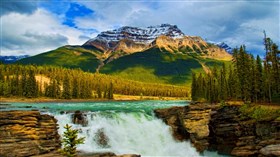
[2,101,224,157]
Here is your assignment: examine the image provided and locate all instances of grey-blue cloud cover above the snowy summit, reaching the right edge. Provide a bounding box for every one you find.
[76,1,280,55]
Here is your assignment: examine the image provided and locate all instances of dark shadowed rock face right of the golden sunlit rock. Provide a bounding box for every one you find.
[209,106,280,156]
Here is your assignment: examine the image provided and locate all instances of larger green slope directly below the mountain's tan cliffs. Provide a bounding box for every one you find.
[100,48,202,85]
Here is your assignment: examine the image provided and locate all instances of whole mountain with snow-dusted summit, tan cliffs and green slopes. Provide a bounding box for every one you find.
[18,24,231,85]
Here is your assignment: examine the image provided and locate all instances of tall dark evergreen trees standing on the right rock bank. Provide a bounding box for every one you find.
[191,37,280,102]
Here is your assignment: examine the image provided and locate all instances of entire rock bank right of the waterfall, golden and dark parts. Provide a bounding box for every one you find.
[155,103,280,156]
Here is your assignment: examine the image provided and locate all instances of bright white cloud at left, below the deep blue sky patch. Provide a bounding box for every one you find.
[1,9,86,55]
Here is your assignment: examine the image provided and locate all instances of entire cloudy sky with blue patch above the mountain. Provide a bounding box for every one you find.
[0,0,280,55]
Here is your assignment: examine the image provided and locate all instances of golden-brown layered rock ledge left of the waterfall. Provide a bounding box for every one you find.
[0,111,60,157]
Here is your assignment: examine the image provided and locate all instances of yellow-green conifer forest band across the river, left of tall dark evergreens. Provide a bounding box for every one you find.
[0,64,188,99]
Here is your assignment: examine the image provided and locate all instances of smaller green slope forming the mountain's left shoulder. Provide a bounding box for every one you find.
[17,46,101,72]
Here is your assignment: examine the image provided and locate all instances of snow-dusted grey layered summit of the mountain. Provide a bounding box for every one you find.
[84,24,184,45]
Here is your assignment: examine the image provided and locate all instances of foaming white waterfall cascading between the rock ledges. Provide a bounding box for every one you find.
[55,111,200,157]
